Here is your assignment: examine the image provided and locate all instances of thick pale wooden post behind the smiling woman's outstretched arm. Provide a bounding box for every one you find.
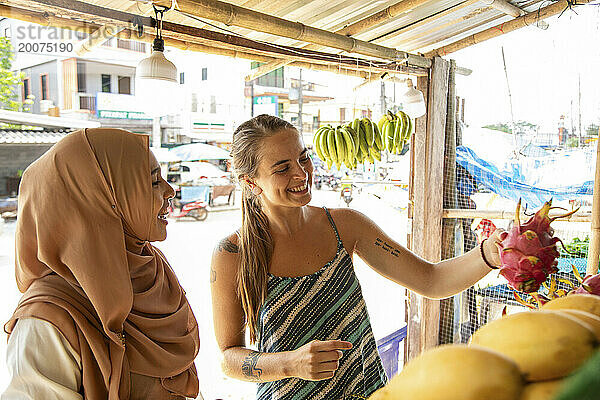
[405,57,449,361]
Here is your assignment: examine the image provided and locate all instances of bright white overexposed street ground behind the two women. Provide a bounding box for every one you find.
[0,190,406,400]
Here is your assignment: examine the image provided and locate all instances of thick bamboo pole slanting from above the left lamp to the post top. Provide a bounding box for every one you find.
[150,0,431,68]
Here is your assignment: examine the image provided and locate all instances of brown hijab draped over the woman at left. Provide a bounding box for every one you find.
[5,128,200,400]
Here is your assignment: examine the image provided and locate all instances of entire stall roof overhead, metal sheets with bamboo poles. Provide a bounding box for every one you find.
[0,0,591,79]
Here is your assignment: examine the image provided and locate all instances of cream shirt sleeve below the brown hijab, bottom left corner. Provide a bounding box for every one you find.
[0,318,83,400]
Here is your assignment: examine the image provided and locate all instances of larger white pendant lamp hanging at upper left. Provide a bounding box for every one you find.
[135,6,180,117]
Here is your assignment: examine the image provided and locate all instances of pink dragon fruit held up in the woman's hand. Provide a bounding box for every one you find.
[498,200,577,293]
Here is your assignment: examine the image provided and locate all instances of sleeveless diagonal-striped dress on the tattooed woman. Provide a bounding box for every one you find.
[256,207,387,400]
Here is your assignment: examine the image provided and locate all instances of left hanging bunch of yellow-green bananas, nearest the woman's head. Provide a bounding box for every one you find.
[313,118,385,170]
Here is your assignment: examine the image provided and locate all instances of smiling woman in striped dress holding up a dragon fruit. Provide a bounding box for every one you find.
[210,115,500,400]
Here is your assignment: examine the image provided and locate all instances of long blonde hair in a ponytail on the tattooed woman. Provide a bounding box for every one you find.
[231,114,296,343]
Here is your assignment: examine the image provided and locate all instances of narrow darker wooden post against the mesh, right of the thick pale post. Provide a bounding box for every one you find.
[439,60,459,344]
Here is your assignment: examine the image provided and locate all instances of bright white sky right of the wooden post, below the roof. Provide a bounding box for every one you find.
[454,5,600,132]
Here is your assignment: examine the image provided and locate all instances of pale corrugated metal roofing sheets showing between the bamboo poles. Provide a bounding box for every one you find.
[0,0,568,61]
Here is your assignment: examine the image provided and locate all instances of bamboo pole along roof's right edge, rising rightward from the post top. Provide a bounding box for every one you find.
[425,0,592,57]
